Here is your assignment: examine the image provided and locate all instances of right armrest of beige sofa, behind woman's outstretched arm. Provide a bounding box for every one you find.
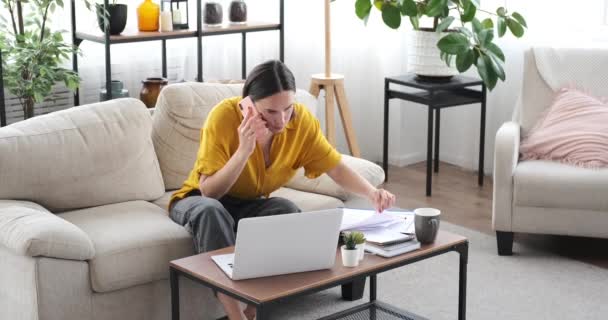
[285,155,384,201]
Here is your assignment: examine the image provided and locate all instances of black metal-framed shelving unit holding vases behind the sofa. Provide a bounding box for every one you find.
[70,0,285,106]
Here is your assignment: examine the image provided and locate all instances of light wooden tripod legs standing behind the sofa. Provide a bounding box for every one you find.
[310,73,361,157]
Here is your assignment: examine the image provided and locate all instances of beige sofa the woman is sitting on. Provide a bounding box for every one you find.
[0,83,384,320]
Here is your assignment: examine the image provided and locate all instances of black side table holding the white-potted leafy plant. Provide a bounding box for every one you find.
[382,74,486,196]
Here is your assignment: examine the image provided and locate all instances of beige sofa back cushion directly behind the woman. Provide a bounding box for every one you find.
[152,82,316,190]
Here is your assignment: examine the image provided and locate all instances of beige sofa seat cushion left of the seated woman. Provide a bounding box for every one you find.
[59,201,194,292]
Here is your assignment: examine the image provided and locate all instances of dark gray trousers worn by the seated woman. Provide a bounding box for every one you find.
[169,195,301,253]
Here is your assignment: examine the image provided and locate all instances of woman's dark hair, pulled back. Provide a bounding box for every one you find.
[243,60,296,101]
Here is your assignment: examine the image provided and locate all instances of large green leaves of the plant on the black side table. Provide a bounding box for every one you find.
[355,0,527,90]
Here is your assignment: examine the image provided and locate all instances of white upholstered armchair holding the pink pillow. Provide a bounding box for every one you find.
[492,48,608,255]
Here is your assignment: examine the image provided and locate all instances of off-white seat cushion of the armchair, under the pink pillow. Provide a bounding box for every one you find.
[513,160,608,212]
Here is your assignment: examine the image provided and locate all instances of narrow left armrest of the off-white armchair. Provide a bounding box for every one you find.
[492,121,520,231]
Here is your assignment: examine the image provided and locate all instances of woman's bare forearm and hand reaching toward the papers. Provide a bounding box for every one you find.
[327,161,395,212]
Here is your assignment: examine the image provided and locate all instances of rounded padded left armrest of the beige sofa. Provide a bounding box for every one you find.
[0,200,95,260]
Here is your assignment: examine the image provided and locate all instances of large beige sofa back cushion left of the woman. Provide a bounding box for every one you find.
[0,99,165,212]
